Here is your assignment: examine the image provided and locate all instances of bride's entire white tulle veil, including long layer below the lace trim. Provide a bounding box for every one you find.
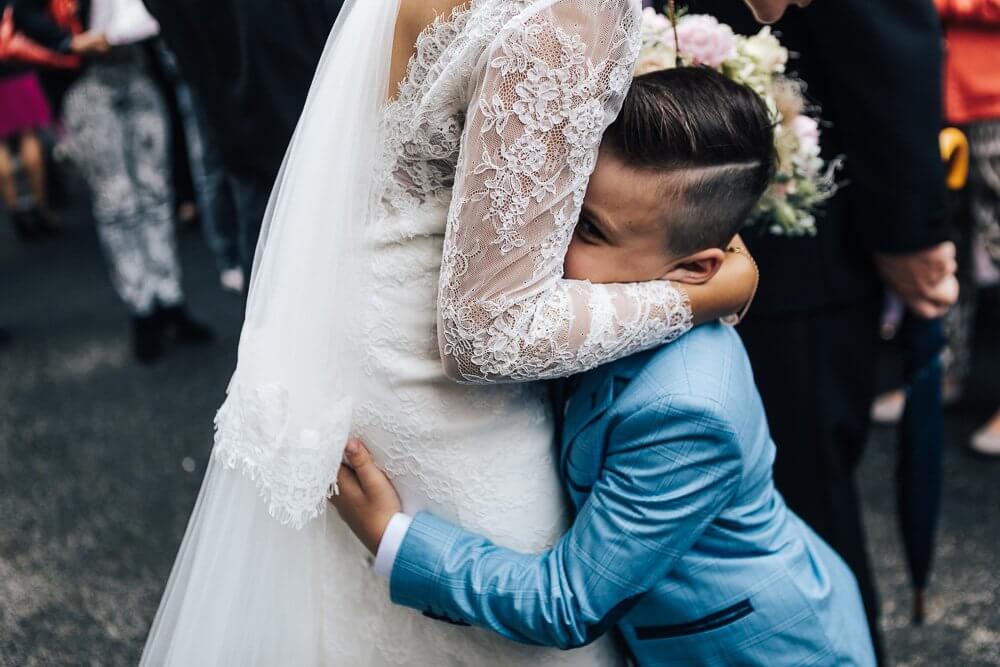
[142,0,399,666]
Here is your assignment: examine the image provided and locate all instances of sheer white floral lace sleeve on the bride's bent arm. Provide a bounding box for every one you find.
[438,0,691,383]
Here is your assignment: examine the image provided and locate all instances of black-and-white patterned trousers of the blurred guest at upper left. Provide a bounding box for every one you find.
[63,47,183,315]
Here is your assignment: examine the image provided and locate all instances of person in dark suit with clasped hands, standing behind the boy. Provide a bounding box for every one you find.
[688,0,957,660]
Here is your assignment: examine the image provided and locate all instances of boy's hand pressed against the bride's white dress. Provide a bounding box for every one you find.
[330,439,403,555]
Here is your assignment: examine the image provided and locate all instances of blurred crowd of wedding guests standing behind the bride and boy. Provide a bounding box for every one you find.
[0,0,1000,664]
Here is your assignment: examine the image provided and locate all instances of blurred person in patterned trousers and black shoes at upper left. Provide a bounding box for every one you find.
[15,0,212,363]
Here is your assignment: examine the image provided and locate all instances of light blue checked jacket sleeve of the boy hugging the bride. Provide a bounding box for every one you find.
[390,398,741,649]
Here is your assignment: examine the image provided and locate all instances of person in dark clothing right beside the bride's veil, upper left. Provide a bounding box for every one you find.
[144,0,344,284]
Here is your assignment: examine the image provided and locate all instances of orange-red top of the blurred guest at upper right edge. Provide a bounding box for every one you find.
[934,0,1000,124]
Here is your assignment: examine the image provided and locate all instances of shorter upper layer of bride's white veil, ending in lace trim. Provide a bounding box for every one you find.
[215,0,399,527]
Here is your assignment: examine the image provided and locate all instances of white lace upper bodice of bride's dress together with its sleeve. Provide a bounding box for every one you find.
[376,0,691,384]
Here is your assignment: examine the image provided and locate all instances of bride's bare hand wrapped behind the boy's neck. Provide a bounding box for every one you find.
[680,235,760,324]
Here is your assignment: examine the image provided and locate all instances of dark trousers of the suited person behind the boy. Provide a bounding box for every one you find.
[739,303,882,662]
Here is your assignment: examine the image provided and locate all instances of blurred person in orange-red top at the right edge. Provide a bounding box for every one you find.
[935,0,1000,456]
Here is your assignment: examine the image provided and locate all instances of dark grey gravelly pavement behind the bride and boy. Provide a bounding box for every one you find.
[0,210,1000,666]
